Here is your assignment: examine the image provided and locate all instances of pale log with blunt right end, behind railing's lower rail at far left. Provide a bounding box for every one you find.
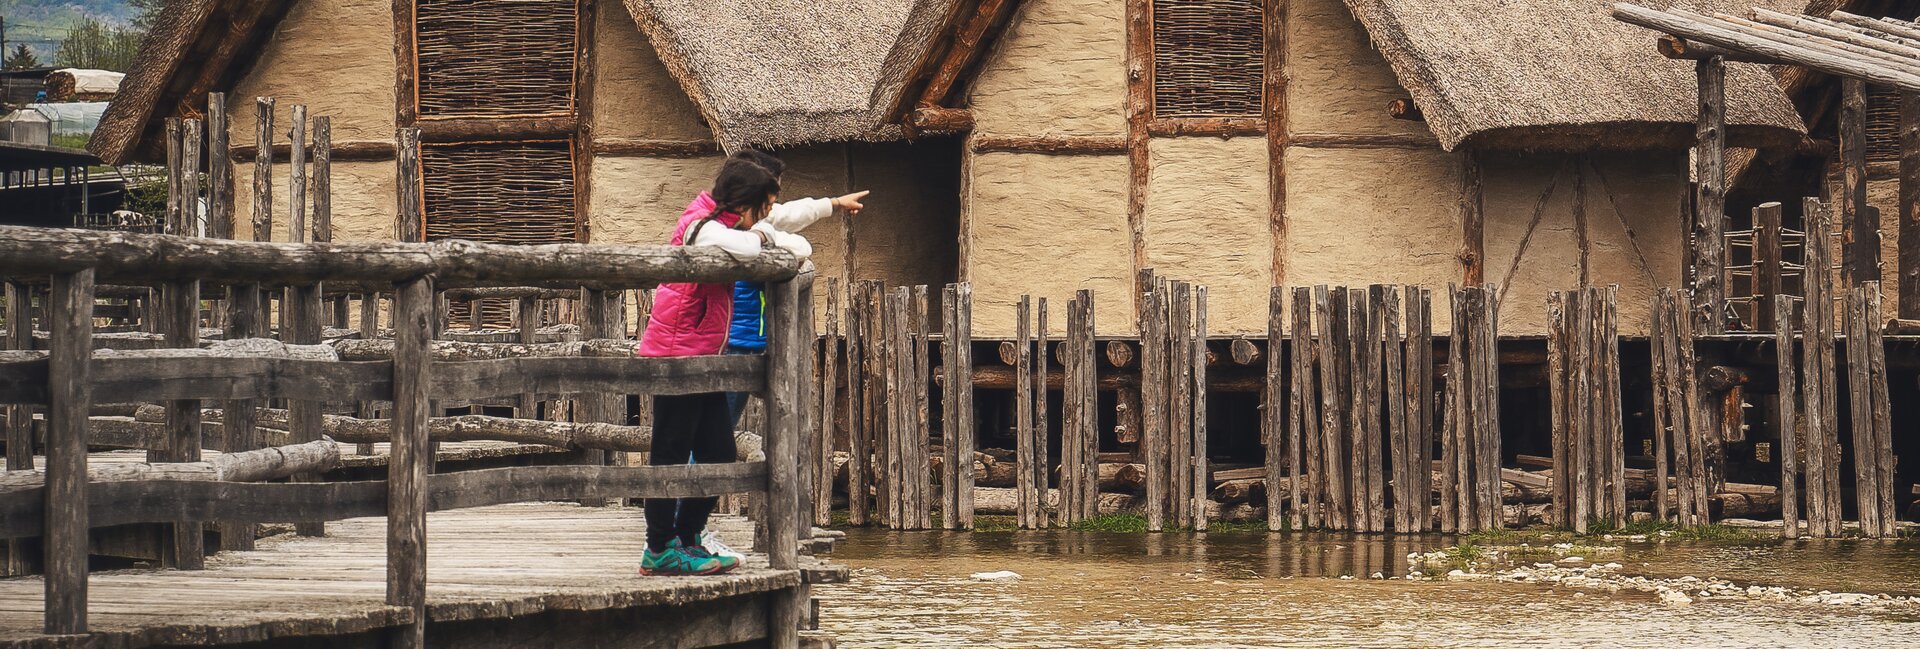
[0,440,340,493]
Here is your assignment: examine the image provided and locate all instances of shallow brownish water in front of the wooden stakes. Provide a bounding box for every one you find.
[814,530,1920,647]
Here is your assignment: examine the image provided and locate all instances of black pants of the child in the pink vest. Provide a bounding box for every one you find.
[647,392,737,551]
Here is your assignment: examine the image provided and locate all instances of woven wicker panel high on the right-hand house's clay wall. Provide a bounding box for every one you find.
[1154,0,1265,117]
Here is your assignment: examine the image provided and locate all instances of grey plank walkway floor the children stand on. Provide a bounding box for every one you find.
[0,503,806,649]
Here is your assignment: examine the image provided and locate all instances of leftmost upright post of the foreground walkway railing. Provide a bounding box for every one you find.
[44,269,94,634]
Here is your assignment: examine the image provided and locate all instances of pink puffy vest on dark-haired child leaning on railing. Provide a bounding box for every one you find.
[634,192,741,357]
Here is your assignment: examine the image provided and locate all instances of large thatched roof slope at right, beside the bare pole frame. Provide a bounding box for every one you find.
[1346,0,1805,150]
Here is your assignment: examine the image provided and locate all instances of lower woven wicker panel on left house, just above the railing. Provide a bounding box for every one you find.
[420,142,580,326]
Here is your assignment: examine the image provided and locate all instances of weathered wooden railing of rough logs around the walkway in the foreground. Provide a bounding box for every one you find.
[0,220,812,647]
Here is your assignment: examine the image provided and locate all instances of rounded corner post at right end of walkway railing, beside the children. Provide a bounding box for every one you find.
[760,269,814,649]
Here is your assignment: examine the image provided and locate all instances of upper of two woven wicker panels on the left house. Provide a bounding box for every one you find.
[413,0,578,117]
